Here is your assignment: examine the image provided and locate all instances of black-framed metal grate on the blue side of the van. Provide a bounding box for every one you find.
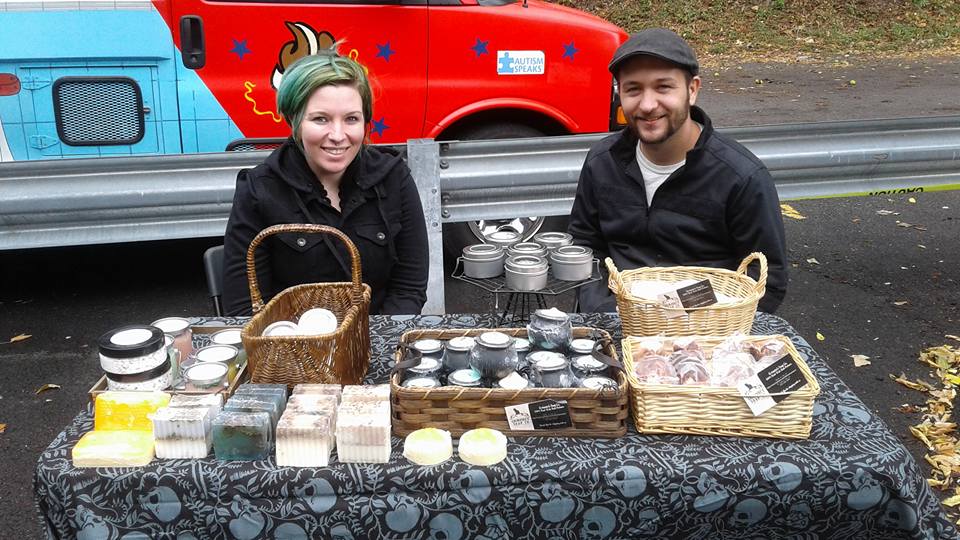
[53,77,144,146]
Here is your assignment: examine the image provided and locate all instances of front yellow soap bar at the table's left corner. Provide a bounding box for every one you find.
[73,430,153,467]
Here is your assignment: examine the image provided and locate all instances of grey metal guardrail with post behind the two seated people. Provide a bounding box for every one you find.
[0,116,960,312]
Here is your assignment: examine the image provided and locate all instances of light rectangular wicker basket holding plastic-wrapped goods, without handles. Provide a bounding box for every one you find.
[622,335,820,439]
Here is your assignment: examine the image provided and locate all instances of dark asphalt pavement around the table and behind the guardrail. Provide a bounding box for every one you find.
[0,58,960,538]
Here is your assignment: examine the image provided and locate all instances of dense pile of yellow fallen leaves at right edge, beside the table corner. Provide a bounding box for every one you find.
[890,345,960,519]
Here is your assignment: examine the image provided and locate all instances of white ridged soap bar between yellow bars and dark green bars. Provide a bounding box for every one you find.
[153,407,213,459]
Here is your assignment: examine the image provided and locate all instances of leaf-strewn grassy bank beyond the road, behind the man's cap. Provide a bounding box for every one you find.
[555,0,960,62]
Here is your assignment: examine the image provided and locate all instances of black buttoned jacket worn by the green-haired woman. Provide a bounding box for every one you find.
[223,139,429,315]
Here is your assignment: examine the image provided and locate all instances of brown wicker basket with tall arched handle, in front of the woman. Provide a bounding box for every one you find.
[240,224,370,387]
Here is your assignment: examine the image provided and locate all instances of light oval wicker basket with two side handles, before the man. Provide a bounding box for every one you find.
[606,253,767,337]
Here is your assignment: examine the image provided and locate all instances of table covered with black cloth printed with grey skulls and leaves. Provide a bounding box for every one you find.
[35,314,958,540]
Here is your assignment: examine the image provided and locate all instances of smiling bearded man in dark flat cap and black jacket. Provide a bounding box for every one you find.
[568,28,787,313]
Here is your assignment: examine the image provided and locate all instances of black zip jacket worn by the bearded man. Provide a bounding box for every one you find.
[568,107,787,313]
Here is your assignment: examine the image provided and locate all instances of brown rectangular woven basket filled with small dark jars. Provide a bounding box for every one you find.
[390,328,628,439]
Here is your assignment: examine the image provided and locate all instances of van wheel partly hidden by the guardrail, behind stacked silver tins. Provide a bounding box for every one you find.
[443,122,544,263]
